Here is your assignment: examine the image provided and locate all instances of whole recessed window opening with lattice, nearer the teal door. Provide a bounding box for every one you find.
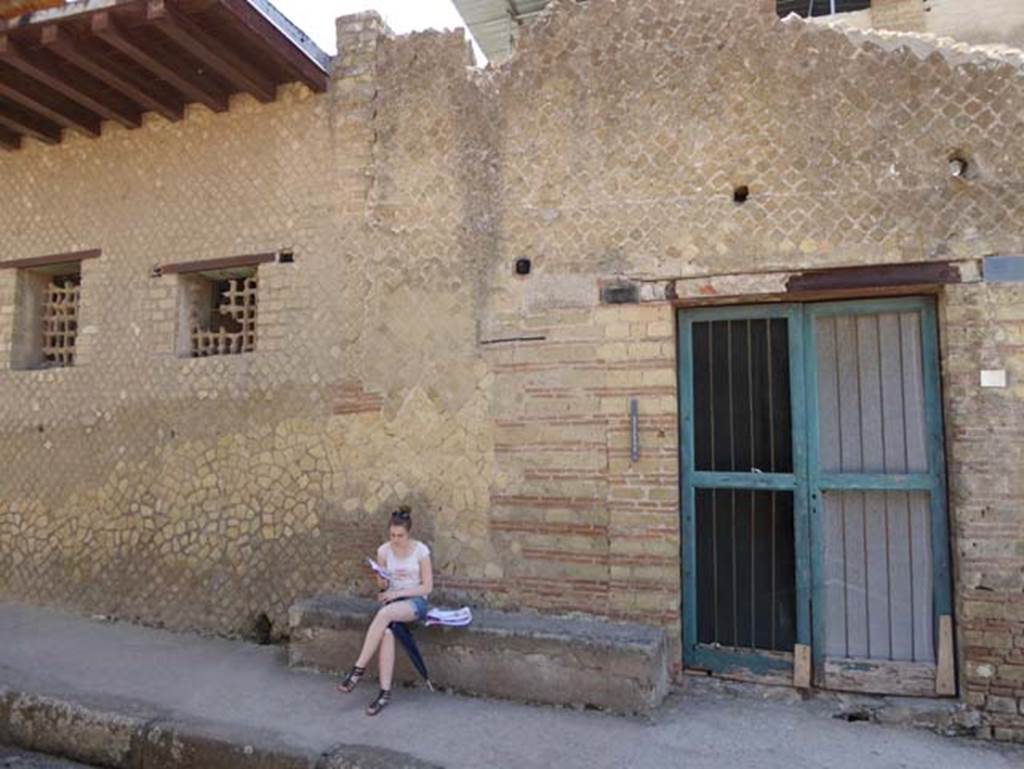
[179,267,259,357]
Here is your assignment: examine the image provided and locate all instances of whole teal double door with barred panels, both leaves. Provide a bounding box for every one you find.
[679,298,950,694]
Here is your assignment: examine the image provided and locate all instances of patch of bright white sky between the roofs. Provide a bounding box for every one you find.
[271,0,481,59]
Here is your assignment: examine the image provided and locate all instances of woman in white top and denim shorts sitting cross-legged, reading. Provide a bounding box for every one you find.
[338,507,434,716]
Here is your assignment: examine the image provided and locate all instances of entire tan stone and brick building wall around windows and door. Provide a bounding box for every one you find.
[0,0,1024,738]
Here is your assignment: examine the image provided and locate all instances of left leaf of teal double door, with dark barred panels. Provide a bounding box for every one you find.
[679,305,811,680]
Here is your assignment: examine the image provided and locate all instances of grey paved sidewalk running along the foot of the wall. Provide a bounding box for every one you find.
[0,604,1024,769]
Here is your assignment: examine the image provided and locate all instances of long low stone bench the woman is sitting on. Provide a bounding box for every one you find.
[289,596,669,714]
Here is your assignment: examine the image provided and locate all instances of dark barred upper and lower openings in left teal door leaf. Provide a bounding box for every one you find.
[692,318,796,651]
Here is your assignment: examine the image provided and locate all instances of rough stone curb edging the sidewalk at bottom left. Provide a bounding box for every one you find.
[0,687,442,769]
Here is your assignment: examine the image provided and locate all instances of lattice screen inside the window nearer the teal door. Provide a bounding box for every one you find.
[191,275,259,357]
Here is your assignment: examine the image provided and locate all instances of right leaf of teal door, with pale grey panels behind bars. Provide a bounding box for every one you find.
[805,299,950,694]
